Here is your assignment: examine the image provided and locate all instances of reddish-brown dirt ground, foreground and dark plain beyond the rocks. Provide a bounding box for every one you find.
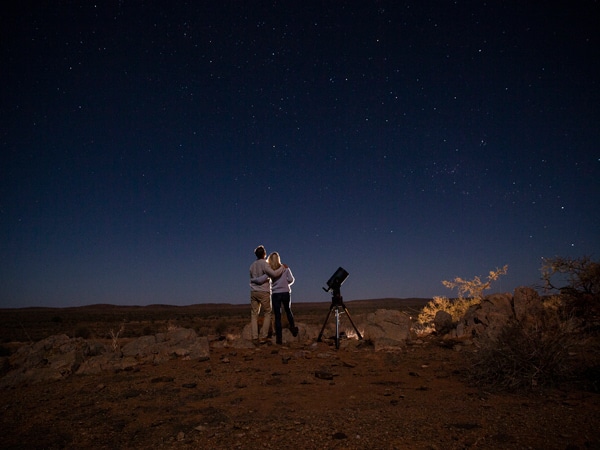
[0,302,600,449]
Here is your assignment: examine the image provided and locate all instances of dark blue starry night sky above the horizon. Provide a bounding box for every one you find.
[0,0,600,308]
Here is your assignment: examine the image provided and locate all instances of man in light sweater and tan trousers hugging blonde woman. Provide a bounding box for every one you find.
[250,245,286,343]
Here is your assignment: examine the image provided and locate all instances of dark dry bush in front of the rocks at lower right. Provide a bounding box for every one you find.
[467,307,586,390]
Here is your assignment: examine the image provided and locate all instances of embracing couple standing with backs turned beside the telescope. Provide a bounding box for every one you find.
[250,245,298,345]
